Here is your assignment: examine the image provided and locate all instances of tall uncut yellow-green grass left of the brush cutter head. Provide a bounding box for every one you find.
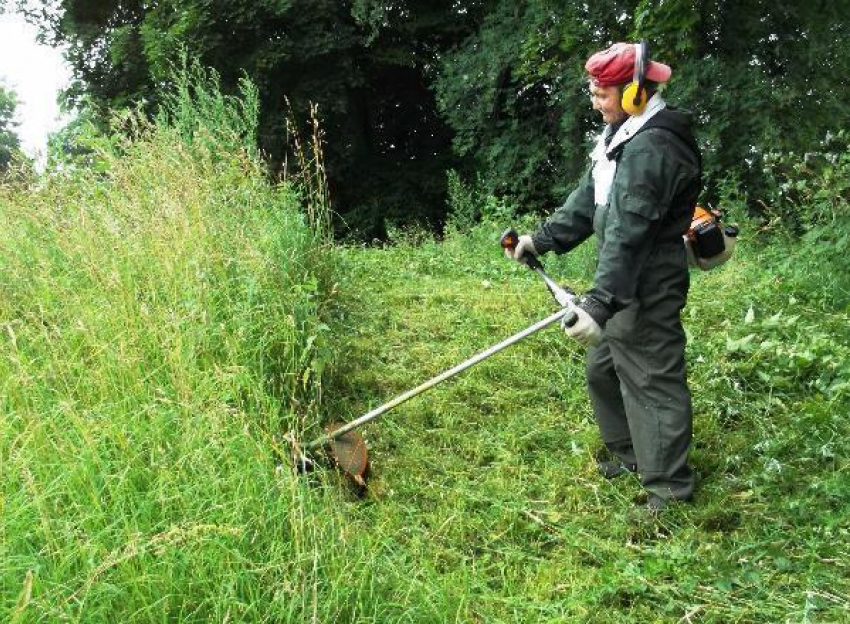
[0,63,374,622]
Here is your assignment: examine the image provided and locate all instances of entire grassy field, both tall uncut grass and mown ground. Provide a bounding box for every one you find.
[0,75,850,623]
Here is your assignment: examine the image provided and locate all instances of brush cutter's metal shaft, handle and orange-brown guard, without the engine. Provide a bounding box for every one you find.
[293,230,578,486]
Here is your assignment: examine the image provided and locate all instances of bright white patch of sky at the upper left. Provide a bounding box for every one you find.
[0,13,71,160]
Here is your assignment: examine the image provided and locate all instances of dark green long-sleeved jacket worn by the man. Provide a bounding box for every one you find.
[532,107,700,324]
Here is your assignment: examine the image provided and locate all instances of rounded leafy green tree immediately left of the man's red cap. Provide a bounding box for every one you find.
[436,0,634,208]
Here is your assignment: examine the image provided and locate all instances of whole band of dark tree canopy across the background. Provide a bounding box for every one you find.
[19,0,850,237]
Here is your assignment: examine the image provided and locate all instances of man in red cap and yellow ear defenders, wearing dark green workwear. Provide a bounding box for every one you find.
[507,43,701,513]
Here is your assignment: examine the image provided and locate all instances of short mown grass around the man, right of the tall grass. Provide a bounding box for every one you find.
[314,217,850,622]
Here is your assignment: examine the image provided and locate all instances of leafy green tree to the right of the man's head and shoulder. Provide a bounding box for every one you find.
[634,0,850,213]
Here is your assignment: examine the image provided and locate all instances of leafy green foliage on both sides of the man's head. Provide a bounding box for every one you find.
[436,0,850,207]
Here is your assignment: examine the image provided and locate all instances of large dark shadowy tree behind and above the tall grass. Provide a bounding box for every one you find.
[19,0,482,237]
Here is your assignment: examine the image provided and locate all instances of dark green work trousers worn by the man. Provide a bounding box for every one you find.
[587,245,694,499]
